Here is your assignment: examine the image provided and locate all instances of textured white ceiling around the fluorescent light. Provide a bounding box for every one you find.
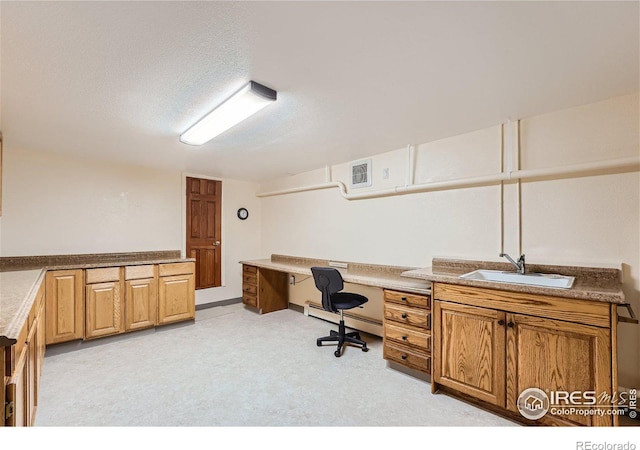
[0,1,640,181]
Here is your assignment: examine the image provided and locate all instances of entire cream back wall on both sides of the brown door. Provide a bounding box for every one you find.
[0,148,261,304]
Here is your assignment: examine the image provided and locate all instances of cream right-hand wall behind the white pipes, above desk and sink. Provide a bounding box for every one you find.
[262,94,640,387]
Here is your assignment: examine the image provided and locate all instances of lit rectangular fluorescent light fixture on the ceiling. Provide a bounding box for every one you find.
[180,81,277,145]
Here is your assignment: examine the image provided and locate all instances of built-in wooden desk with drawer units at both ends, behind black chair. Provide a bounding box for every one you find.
[241,255,431,374]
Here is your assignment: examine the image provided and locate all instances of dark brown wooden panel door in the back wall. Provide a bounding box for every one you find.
[187,177,222,289]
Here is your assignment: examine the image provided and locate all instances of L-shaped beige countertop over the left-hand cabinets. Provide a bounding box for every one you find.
[0,254,195,346]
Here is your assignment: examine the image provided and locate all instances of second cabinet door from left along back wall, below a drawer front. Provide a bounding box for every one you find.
[85,281,124,339]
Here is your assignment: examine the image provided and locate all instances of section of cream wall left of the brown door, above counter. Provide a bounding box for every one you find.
[0,147,182,256]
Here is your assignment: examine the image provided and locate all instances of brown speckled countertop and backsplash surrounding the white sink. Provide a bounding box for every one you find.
[402,258,625,304]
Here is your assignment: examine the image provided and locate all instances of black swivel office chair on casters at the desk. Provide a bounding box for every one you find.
[311,267,369,357]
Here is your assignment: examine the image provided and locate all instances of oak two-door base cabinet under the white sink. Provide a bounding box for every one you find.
[432,283,617,426]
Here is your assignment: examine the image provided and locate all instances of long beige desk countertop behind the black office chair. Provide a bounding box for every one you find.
[240,255,431,294]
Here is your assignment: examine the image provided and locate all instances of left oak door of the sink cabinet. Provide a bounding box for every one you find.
[433,301,505,406]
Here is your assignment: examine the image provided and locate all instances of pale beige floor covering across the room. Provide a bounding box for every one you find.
[36,304,515,427]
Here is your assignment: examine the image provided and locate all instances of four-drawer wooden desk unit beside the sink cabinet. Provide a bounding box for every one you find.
[383,289,431,375]
